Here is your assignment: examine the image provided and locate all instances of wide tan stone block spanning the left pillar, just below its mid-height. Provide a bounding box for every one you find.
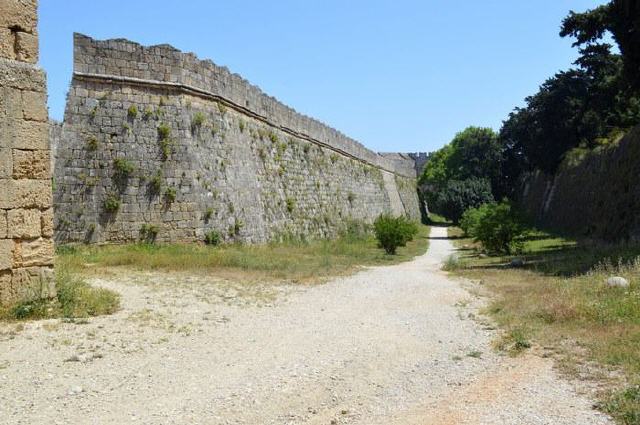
[0,179,52,209]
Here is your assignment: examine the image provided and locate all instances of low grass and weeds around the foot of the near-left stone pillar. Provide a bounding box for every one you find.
[0,262,120,321]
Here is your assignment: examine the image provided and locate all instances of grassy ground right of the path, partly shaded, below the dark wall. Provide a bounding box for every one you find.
[447,227,640,425]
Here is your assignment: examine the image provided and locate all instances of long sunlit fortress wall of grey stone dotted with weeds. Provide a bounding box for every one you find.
[52,34,419,243]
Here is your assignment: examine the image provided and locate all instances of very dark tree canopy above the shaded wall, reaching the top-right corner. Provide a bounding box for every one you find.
[500,0,640,187]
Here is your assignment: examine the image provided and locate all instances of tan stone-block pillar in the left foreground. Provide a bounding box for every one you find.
[0,0,55,305]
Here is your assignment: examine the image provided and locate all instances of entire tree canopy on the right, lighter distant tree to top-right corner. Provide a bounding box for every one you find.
[420,0,640,207]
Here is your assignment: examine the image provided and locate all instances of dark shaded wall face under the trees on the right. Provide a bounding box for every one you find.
[520,127,640,242]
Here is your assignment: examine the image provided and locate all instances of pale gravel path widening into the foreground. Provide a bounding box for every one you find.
[0,227,611,425]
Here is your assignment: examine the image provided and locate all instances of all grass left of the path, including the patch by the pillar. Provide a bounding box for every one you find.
[0,225,429,320]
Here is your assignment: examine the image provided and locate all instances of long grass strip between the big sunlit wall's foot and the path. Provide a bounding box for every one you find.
[57,226,429,282]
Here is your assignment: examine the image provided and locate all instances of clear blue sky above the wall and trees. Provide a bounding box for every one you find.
[39,0,604,152]
